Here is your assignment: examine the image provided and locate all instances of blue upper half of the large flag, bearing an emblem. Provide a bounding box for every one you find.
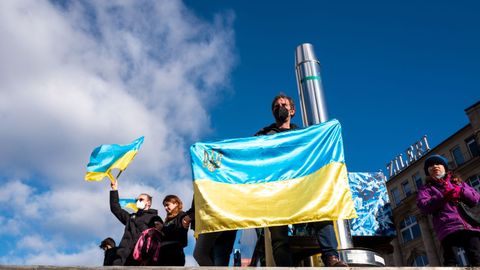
[190,120,345,184]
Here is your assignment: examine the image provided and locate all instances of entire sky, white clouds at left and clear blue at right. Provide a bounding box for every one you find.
[0,0,480,265]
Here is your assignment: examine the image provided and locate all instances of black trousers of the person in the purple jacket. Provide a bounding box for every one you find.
[442,230,480,266]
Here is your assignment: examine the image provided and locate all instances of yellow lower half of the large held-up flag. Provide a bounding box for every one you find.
[194,162,357,234]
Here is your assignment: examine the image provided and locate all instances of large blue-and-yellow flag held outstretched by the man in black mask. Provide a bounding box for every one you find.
[190,120,356,234]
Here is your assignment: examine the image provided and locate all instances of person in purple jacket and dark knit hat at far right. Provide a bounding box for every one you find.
[417,155,480,266]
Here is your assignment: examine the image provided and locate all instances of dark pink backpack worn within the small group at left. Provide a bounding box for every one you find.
[133,228,162,263]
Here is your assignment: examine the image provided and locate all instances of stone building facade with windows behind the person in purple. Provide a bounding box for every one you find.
[387,102,480,266]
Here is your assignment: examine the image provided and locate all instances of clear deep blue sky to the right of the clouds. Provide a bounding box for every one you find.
[187,1,480,171]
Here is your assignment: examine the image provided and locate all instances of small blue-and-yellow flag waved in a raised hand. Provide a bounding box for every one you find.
[85,136,144,181]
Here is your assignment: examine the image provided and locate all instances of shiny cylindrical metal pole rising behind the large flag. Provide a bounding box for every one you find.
[295,43,353,249]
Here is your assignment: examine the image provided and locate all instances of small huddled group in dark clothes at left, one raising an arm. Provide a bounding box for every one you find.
[104,176,188,266]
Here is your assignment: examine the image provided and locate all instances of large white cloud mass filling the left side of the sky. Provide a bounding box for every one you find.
[0,0,235,265]
